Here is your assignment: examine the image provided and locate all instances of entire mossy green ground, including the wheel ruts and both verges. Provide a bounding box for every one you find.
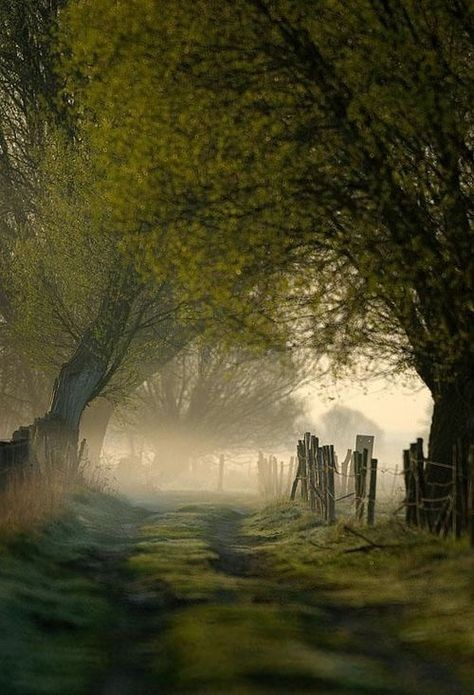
[0,495,474,695]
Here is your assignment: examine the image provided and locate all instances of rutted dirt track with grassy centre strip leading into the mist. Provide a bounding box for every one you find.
[96,505,467,695]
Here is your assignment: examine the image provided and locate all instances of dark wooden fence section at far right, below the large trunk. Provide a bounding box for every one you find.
[403,439,474,547]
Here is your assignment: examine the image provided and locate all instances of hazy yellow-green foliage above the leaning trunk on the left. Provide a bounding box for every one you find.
[9,134,118,373]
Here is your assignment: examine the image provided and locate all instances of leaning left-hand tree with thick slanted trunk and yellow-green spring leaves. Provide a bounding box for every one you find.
[10,139,194,448]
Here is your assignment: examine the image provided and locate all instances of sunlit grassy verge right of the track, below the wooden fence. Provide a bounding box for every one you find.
[246,504,474,692]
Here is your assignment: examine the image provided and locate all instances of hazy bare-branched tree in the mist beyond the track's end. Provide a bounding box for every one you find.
[118,339,305,476]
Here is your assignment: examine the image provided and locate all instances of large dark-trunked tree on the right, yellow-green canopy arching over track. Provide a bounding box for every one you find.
[61,0,474,492]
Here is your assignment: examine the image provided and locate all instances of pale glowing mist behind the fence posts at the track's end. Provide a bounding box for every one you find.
[94,370,431,496]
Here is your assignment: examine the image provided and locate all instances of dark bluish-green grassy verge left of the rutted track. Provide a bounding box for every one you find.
[0,492,142,695]
